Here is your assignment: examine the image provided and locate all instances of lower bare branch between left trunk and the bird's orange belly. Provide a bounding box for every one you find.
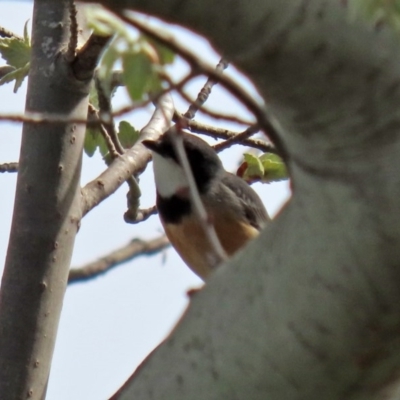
[68,235,169,284]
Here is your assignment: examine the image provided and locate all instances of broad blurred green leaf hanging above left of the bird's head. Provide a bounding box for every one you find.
[122,52,156,101]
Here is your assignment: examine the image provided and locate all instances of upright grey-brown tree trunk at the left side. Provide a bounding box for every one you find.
[0,0,89,400]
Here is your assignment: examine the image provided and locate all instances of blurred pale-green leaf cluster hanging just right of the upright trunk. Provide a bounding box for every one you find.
[85,7,175,158]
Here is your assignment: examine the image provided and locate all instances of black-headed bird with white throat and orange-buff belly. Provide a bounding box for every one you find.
[142,130,270,281]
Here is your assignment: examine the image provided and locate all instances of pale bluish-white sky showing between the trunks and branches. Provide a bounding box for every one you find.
[0,0,290,400]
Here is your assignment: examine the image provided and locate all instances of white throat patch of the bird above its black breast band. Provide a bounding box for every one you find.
[152,151,189,197]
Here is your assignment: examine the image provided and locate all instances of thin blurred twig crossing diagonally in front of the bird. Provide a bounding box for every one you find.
[171,124,227,268]
